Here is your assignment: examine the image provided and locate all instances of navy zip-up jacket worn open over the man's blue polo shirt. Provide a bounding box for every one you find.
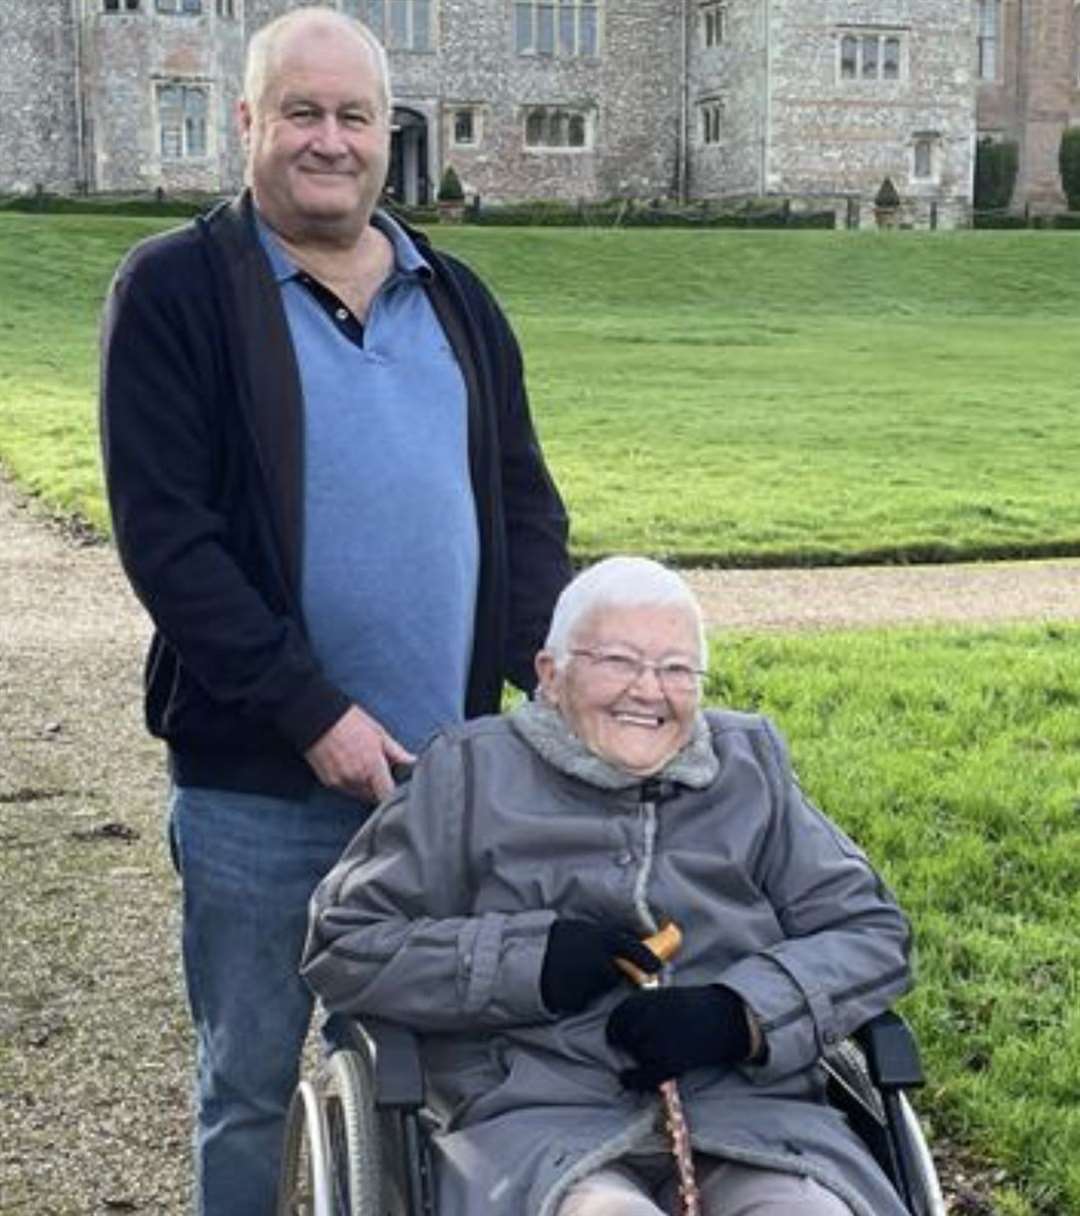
[101,192,570,796]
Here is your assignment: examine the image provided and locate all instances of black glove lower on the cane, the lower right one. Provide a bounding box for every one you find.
[607,984,750,1090]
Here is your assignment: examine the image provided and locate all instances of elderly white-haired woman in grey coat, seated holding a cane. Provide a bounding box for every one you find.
[304,557,910,1216]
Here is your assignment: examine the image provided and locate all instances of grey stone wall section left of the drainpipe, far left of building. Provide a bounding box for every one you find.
[0,0,84,193]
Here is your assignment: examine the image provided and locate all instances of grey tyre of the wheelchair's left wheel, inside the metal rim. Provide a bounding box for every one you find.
[320,1049,383,1216]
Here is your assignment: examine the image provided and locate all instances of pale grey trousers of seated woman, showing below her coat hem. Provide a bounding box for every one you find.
[558,1158,851,1216]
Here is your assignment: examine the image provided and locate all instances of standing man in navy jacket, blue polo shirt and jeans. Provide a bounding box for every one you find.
[102,7,568,1216]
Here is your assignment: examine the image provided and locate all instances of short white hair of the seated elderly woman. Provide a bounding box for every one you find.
[544,557,709,668]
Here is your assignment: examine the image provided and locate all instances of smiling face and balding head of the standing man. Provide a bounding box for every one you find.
[241,26,389,241]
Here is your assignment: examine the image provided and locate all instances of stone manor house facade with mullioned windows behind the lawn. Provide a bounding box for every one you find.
[0,0,1080,225]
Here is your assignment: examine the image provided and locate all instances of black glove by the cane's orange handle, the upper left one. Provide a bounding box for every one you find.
[540,918,663,1013]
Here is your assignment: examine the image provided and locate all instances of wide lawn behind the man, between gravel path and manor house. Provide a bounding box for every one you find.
[0,214,1080,564]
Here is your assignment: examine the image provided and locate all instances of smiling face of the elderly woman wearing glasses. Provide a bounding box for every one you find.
[536,604,699,777]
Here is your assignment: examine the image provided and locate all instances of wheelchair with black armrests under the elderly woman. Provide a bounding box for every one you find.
[277,1012,946,1216]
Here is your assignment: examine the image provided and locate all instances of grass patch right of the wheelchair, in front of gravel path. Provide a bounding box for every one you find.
[707,626,1080,1216]
